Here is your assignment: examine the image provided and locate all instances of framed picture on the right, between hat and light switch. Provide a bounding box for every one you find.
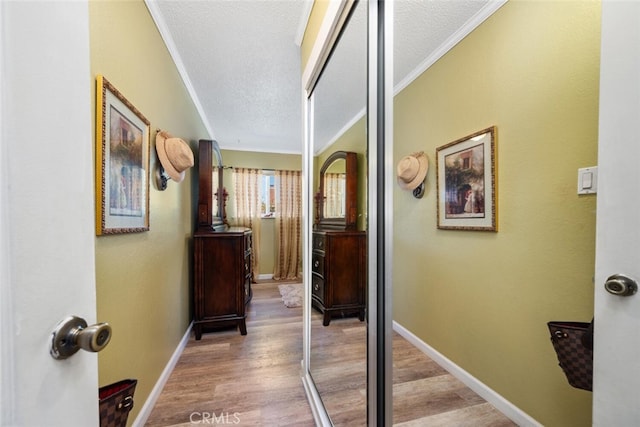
[436,126,498,231]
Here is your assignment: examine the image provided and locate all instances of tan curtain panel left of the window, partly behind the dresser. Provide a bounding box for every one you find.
[233,168,262,282]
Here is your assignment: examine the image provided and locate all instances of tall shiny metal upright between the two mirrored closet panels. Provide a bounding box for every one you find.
[367,0,395,426]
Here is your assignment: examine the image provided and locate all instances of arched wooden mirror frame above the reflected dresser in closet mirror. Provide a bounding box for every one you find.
[316,151,358,230]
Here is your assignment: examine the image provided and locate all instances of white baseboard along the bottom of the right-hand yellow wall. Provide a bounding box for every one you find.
[393,320,542,427]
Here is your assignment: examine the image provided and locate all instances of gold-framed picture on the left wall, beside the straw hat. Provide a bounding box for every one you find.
[96,75,150,236]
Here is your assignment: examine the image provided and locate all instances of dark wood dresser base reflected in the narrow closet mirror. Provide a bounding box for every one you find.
[311,230,367,326]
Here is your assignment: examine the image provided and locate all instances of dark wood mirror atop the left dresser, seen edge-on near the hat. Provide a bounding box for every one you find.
[197,139,226,230]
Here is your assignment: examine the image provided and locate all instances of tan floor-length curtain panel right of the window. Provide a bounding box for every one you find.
[273,171,302,280]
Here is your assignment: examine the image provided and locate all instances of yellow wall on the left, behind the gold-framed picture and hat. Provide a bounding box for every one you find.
[89,0,208,423]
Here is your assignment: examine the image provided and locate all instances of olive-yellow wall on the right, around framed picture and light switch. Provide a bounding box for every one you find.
[393,1,600,427]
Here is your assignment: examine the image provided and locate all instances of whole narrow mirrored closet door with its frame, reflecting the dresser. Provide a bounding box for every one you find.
[303,1,390,426]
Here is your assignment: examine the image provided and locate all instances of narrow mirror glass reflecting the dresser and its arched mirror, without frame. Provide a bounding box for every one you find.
[309,3,367,426]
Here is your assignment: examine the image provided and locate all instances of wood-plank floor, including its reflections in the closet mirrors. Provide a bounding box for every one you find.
[146,283,515,427]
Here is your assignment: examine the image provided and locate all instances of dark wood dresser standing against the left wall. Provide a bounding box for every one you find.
[193,227,251,340]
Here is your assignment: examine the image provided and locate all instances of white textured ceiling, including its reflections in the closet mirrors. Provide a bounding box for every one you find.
[147,0,502,153]
